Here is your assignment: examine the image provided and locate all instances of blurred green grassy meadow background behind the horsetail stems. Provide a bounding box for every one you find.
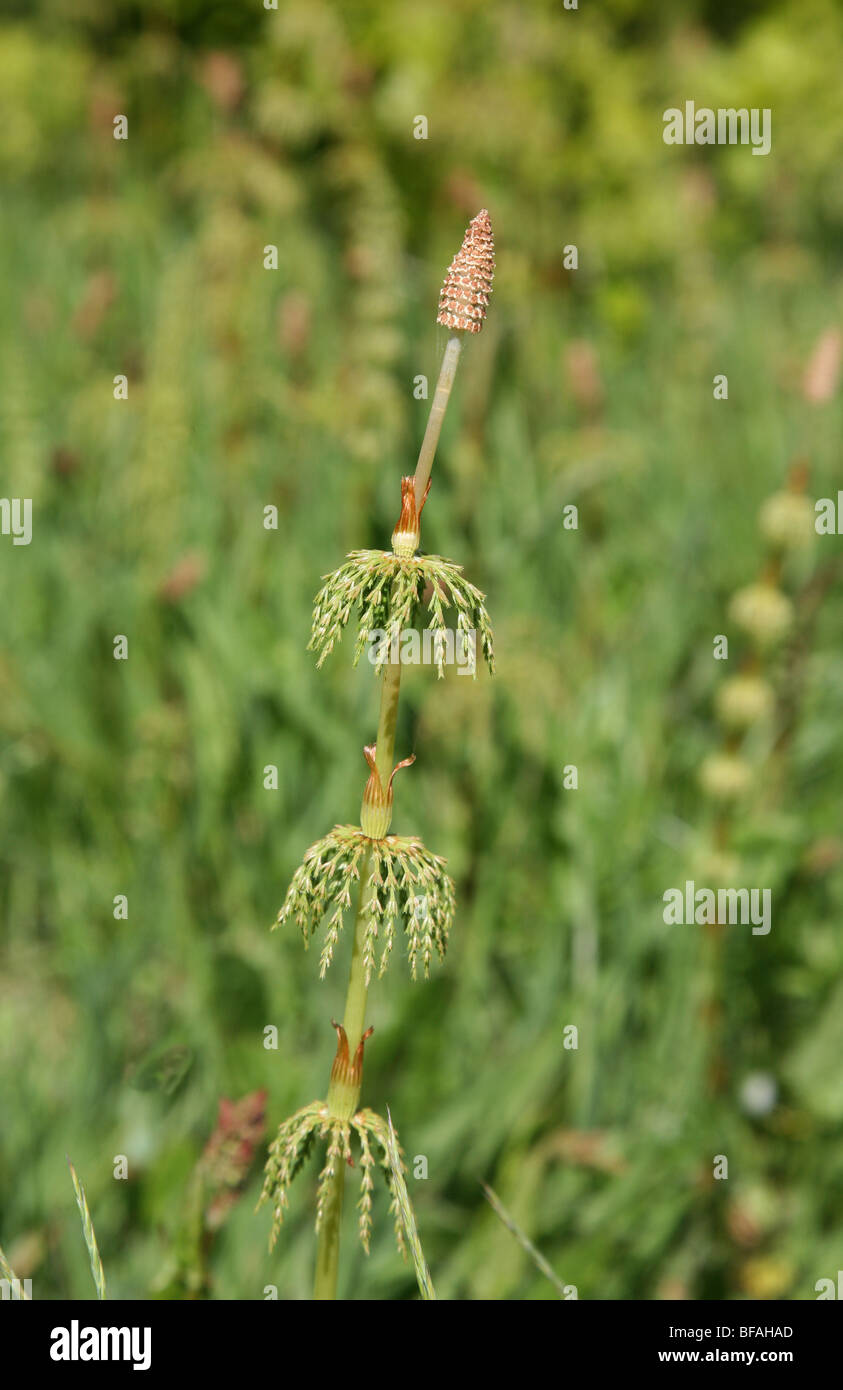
[0,0,843,1298]
